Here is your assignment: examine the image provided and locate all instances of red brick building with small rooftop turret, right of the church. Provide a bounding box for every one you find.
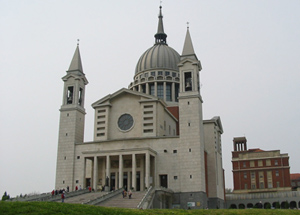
[232,137,291,193]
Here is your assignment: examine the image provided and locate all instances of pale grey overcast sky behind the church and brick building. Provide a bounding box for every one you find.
[0,0,300,196]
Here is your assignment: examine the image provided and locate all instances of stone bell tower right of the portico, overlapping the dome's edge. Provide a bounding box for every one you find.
[178,28,207,202]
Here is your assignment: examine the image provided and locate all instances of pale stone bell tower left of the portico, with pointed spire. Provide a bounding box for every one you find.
[55,44,88,191]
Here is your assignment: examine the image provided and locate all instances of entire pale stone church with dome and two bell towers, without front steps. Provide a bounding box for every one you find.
[55,7,225,208]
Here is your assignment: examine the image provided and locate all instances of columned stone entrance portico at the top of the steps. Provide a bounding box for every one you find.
[82,148,157,191]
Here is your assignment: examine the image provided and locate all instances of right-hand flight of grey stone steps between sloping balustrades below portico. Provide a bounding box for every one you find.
[97,191,146,208]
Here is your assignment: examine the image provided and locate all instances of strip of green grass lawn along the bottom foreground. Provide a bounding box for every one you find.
[0,202,300,215]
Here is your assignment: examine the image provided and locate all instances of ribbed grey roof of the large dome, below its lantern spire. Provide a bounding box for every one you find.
[135,43,180,74]
